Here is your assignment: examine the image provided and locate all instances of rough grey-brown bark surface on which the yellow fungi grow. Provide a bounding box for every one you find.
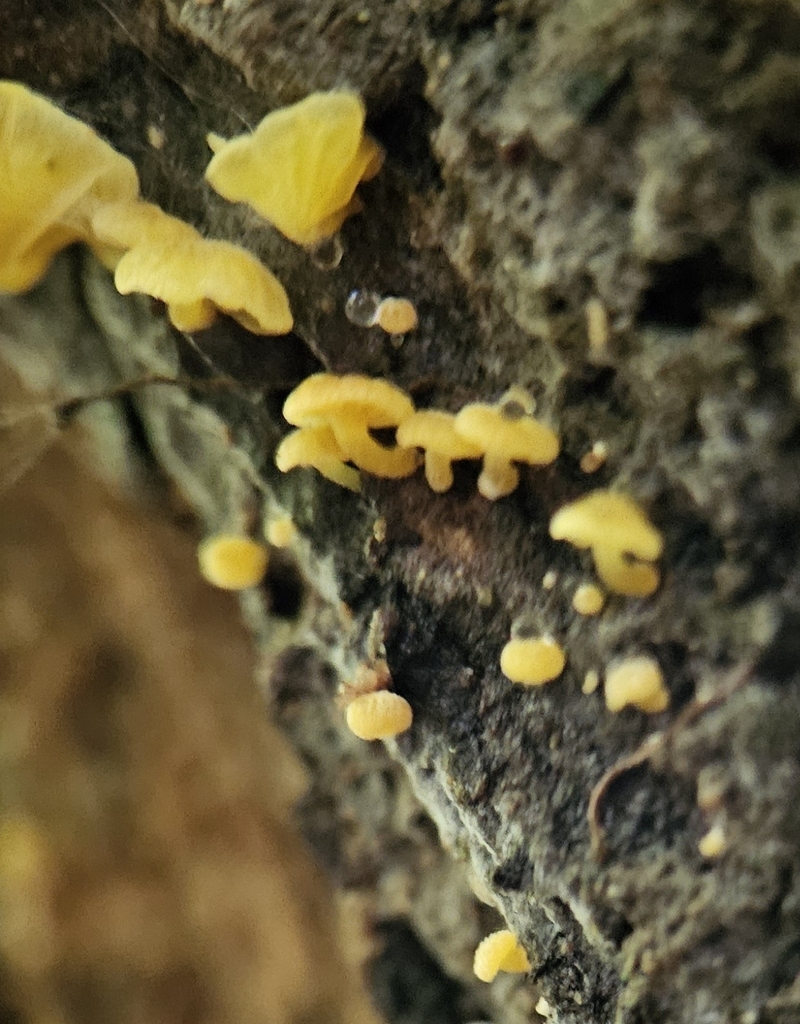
[0,0,800,1024]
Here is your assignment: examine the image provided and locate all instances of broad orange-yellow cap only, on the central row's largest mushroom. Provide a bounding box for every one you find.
[284,373,414,428]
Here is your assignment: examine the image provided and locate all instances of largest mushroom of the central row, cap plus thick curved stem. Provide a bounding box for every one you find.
[284,374,418,478]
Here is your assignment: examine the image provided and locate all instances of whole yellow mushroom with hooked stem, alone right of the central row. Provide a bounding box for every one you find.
[550,490,664,597]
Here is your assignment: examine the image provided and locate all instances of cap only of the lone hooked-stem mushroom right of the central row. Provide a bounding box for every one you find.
[550,490,664,561]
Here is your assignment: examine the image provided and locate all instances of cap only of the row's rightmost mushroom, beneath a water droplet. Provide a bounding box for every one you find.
[456,402,559,466]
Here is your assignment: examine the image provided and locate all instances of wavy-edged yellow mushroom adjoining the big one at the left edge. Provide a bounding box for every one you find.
[92,203,292,334]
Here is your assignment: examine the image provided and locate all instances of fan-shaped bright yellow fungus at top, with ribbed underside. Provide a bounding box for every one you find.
[206,91,383,246]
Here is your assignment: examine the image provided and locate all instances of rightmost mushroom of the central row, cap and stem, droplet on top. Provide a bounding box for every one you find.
[455,396,559,502]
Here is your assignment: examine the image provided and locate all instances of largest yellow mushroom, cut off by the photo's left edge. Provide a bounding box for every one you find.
[0,81,139,292]
